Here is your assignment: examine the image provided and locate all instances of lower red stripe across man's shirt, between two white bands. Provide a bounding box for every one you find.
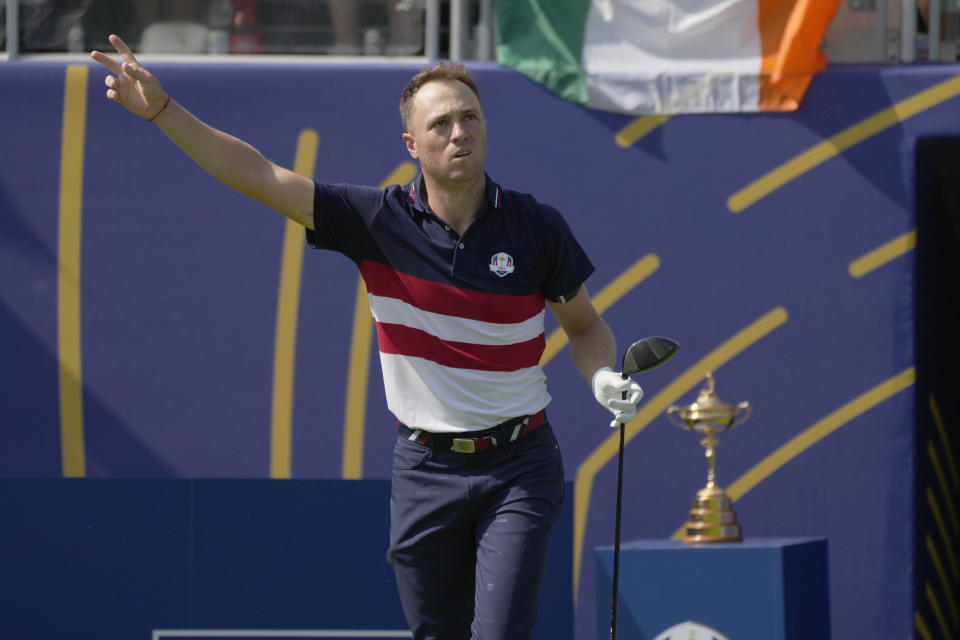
[377,322,546,371]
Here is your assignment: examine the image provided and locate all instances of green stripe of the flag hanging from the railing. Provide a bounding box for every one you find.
[494,0,590,104]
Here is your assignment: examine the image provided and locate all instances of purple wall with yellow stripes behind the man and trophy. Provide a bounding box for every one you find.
[0,61,960,638]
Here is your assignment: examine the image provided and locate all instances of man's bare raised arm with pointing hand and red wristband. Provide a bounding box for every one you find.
[90,35,313,229]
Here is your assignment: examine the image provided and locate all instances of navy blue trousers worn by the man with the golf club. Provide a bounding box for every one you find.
[388,424,565,640]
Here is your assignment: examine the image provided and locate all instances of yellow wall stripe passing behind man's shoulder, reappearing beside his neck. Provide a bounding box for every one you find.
[341,162,417,480]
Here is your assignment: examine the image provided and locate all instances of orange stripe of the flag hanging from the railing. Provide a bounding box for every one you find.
[757,0,840,111]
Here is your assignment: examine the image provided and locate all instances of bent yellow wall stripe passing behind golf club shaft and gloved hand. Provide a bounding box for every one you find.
[573,307,787,602]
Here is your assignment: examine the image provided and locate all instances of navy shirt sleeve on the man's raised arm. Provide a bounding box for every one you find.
[307,182,385,262]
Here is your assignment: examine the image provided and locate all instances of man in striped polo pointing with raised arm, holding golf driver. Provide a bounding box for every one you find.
[91,36,642,640]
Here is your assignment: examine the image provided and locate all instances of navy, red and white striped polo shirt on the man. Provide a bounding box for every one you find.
[307,175,593,433]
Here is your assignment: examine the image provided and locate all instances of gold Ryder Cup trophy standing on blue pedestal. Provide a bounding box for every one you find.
[667,373,750,542]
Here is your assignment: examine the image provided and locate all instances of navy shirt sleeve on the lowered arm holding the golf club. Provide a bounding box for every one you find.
[537,204,594,302]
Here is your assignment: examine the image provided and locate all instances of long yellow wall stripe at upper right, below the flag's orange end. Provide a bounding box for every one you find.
[727,76,960,213]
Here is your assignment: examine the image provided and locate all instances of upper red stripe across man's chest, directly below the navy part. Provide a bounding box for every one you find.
[360,260,544,324]
